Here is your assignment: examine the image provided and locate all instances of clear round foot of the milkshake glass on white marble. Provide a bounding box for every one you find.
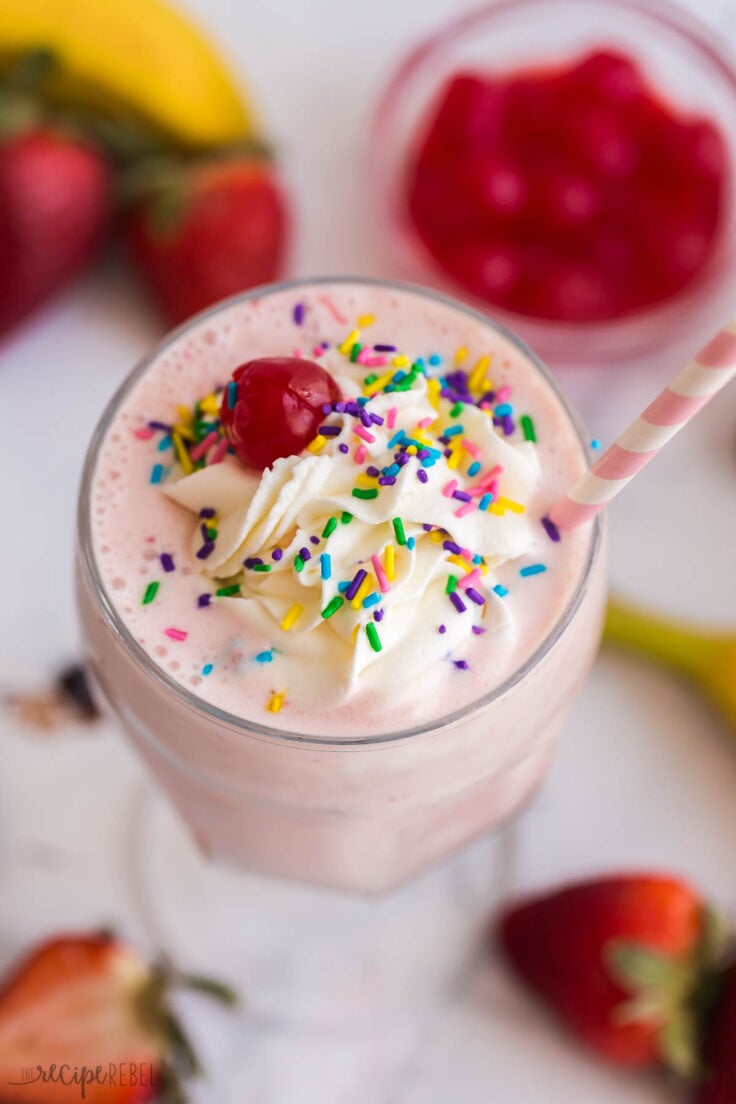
[138,790,515,1032]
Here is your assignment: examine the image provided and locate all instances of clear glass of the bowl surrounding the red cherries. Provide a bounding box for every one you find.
[369,0,736,365]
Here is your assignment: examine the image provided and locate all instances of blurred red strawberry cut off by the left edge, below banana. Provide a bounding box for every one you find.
[0,127,111,336]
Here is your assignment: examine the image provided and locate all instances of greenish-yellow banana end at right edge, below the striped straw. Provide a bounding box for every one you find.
[604,599,736,742]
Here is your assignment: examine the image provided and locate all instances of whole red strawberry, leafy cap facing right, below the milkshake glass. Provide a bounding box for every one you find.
[499,874,706,1073]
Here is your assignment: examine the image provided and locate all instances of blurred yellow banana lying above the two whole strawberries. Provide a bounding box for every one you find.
[0,0,254,148]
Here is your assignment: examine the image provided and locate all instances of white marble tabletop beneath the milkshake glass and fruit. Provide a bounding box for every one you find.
[0,0,736,1104]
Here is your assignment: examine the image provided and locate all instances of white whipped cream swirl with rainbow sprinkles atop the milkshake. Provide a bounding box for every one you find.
[163,354,540,708]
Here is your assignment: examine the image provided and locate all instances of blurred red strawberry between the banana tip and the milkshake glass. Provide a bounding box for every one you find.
[128,157,288,323]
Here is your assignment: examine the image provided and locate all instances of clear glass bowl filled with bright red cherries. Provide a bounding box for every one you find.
[370,0,736,364]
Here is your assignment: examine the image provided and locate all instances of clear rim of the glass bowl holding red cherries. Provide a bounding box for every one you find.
[370,0,736,362]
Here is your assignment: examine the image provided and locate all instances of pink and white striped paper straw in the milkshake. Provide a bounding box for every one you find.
[550,316,736,529]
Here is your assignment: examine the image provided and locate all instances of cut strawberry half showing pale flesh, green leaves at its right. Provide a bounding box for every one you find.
[0,934,235,1104]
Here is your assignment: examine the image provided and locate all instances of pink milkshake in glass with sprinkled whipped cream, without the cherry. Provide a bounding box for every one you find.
[78,279,605,892]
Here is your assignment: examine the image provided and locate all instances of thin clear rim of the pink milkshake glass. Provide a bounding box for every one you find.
[77,276,602,749]
